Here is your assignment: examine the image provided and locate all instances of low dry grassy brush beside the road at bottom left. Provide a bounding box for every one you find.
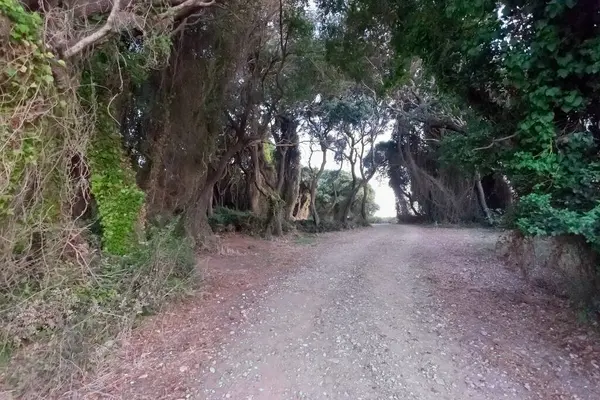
[0,221,195,397]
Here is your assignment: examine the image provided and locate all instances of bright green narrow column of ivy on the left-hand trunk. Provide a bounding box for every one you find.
[89,110,144,255]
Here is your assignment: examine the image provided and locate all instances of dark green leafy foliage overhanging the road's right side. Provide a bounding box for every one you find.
[320,0,600,247]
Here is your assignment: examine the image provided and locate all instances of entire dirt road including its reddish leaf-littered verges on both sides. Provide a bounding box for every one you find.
[82,225,600,400]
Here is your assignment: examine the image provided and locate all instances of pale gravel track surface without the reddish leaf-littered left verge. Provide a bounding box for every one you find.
[195,225,600,400]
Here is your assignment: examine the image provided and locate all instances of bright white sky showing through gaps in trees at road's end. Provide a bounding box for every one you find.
[300,135,396,218]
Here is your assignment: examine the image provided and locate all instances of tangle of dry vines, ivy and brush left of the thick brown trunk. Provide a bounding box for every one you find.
[0,0,195,398]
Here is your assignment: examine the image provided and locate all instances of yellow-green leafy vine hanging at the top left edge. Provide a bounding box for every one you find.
[0,0,64,223]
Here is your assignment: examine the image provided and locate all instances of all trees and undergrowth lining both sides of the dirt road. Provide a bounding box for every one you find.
[0,0,600,397]
